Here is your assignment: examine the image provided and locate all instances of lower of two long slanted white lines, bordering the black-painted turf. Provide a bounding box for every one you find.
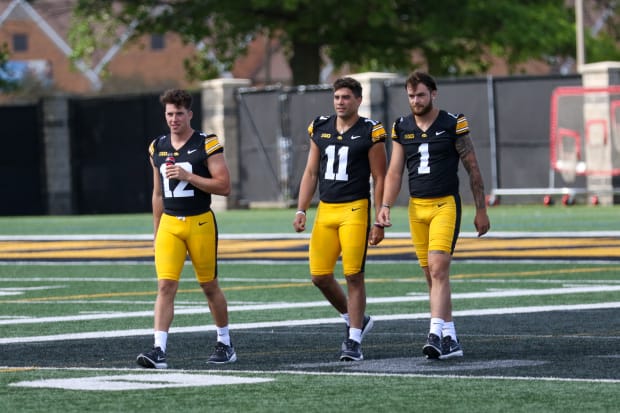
[0,302,620,344]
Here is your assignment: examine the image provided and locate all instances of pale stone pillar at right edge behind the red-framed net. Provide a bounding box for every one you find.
[581,62,620,205]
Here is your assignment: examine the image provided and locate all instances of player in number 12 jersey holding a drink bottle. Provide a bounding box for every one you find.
[137,89,237,368]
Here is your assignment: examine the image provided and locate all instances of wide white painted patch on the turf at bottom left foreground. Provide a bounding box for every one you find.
[9,373,274,391]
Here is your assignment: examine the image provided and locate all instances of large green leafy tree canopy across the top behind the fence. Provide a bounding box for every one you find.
[70,0,604,84]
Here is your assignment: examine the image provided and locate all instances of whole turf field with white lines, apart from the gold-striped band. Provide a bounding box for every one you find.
[0,206,620,412]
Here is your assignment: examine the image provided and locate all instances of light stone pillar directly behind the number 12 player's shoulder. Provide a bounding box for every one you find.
[202,79,251,211]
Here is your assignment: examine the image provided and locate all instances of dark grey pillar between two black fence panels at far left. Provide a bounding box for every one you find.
[42,95,74,215]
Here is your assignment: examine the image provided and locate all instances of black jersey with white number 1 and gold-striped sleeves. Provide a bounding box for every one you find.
[392,110,469,198]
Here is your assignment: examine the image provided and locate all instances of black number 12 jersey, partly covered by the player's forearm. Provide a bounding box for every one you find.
[149,131,224,216]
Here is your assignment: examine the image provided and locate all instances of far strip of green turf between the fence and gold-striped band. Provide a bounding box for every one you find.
[0,205,620,235]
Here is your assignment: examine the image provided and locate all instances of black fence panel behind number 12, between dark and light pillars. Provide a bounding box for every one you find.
[70,94,202,214]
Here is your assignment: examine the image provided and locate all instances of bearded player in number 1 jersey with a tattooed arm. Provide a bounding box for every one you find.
[378,72,490,359]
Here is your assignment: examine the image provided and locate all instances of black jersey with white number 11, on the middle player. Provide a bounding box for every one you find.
[308,115,387,203]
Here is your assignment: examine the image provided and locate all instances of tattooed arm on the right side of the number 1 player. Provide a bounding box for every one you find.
[455,134,491,236]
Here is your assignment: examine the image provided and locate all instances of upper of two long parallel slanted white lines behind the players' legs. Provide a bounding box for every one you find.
[0,285,620,326]
